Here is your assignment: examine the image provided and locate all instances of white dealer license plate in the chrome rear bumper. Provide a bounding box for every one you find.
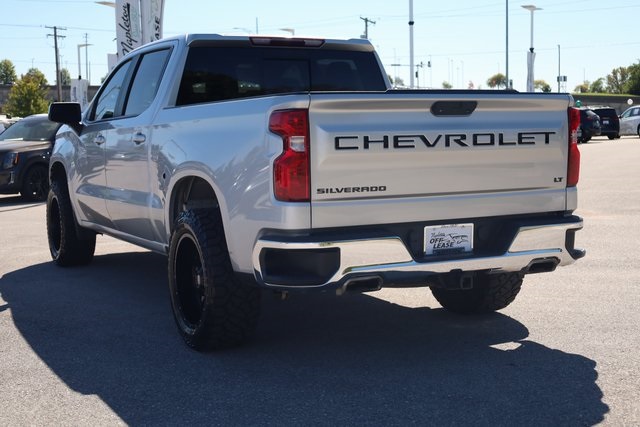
[424,224,473,255]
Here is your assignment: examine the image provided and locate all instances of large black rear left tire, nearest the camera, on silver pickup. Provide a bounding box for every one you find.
[169,209,260,351]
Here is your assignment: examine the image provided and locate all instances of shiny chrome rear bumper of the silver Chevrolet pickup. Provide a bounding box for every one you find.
[253,217,585,289]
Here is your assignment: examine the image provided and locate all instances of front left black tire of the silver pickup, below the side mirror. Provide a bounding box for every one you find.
[47,181,96,267]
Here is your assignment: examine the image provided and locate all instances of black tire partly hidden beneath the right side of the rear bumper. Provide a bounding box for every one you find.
[431,273,523,314]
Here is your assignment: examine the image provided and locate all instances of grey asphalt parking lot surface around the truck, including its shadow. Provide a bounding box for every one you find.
[0,137,640,426]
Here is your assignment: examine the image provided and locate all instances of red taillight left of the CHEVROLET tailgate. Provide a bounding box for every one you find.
[269,110,311,202]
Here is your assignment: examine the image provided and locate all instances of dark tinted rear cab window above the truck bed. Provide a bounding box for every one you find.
[176,45,386,106]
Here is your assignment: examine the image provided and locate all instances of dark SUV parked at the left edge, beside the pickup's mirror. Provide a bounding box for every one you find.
[0,114,61,201]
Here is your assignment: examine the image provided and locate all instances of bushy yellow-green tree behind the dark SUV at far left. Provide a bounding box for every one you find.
[5,72,49,117]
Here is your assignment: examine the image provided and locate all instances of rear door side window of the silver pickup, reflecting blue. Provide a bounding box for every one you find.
[124,49,169,116]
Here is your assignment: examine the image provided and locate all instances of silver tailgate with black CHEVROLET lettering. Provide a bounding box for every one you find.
[309,91,571,228]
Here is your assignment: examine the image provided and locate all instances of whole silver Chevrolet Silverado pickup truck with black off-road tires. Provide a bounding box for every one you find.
[47,35,585,350]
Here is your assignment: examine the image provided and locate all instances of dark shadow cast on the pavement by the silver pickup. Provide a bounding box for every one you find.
[0,252,608,426]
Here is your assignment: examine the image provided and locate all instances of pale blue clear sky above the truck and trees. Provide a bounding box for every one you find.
[0,0,640,92]
